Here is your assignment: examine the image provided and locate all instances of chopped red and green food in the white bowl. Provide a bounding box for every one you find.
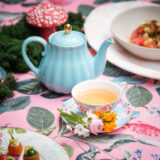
[130,20,160,48]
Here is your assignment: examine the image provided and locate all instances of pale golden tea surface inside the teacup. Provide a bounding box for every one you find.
[76,88,118,105]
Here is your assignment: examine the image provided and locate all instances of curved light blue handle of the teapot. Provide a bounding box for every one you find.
[22,36,47,75]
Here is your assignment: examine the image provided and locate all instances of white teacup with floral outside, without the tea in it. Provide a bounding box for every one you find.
[71,79,127,114]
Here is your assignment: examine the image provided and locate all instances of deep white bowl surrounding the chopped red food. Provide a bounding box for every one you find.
[111,6,160,60]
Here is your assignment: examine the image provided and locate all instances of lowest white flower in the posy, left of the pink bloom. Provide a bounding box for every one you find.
[74,124,90,137]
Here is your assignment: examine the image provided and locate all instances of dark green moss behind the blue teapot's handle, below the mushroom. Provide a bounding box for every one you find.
[0,17,43,73]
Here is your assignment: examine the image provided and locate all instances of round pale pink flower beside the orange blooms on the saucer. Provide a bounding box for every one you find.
[90,119,103,135]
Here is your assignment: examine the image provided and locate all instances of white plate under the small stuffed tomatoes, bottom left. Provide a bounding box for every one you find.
[0,128,69,160]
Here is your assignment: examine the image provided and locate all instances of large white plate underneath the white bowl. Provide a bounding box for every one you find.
[84,1,160,79]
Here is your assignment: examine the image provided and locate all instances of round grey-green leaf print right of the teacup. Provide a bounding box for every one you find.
[126,86,152,107]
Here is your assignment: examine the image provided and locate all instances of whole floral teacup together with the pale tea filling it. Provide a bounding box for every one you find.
[71,80,125,114]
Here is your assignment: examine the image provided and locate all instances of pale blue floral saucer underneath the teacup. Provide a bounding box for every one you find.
[61,98,140,129]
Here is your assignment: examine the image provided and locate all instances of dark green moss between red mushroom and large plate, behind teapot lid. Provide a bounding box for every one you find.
[56,12,84,32]
